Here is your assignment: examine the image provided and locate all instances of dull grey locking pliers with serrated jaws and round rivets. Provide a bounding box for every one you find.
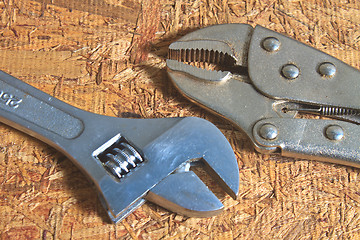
[167,24,360,167]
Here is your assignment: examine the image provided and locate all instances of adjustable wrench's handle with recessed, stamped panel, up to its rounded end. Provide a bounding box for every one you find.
[0,71,84,142]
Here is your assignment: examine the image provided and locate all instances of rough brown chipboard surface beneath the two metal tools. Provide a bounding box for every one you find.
[0,0,360,239]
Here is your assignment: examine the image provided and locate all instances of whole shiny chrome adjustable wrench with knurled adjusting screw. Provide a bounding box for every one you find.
[0,71,239,222]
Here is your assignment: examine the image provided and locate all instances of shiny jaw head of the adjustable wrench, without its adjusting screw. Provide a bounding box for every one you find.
[98,117,239,222]
